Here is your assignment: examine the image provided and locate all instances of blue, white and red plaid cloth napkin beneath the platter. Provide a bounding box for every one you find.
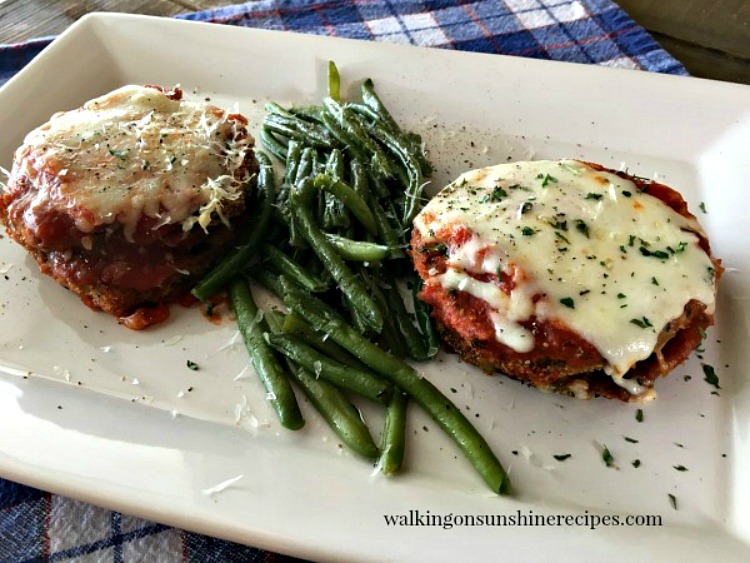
[0,0,687,563]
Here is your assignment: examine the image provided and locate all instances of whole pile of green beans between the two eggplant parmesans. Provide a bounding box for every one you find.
[193,62,510,494]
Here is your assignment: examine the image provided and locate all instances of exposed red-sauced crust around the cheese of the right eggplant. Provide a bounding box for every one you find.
[410,163,722,402]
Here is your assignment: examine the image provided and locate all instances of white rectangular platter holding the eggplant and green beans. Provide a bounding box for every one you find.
[0,15,750,561]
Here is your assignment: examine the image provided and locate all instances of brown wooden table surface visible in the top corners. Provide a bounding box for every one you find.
[0,0,750,84]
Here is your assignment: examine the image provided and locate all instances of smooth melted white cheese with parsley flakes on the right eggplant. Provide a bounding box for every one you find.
[414,161,715,382]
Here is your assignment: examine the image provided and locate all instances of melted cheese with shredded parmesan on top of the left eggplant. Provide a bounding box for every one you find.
[16,86,252,237]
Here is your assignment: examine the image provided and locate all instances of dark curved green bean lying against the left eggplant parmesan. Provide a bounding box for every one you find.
[192,152,276,301]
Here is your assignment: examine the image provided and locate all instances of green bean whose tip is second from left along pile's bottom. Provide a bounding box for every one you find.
[290,362,380,459]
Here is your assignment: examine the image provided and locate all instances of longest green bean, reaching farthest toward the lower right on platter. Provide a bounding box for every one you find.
[281,278,510,494]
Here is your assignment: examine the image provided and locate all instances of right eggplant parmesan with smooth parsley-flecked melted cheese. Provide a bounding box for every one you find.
[411,160,722,401]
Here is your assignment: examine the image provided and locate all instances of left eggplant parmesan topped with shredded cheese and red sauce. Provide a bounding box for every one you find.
[0,86,257,328]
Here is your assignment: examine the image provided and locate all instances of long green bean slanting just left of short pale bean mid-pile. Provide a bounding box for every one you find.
[291,179,383,333]
